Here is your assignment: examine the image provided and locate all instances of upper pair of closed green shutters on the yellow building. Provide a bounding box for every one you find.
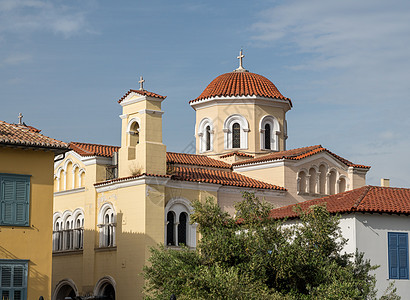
[0,175,30,226]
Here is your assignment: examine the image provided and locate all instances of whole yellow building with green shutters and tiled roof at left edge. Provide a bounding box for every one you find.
[0,121,68,300]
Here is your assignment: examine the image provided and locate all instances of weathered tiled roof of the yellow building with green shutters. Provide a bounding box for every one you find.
[0,121,68,150]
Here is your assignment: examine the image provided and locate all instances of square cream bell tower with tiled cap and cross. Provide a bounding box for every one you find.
[118,76,166,177]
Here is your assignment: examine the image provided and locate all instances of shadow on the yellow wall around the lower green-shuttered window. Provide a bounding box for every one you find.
[0,246,51,299]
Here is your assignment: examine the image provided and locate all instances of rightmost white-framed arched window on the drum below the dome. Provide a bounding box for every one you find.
[259,115,280,151]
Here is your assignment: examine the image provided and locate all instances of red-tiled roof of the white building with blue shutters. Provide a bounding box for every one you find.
[270,186,410,219]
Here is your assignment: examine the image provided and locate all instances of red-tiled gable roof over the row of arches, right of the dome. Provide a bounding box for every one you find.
[232,145,370,169]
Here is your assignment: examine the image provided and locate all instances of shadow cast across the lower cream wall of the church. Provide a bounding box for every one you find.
[52,213,156,300]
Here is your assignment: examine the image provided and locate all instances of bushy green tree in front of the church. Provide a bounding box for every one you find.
[144,193,398,300]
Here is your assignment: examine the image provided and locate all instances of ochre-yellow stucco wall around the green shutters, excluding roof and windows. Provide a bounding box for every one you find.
[0,147,54,299]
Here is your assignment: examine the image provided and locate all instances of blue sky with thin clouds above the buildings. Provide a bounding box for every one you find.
[0,0,410,187]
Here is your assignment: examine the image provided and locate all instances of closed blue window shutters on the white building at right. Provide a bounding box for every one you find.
[387,232,409,280]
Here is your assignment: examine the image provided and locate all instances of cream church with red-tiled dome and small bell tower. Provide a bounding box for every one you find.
[52,51,370,300]
